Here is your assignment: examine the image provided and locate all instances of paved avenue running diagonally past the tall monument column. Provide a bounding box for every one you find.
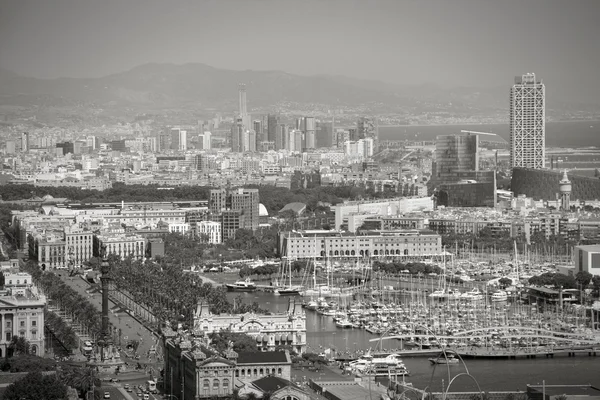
[59,271,162,379]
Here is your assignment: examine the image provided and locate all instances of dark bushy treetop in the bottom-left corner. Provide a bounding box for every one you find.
[4,372,67,400]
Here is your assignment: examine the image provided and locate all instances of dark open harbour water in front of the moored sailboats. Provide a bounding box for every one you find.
[229,292,600,391]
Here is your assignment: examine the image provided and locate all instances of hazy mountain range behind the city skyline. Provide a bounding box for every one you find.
[0,63,596,111]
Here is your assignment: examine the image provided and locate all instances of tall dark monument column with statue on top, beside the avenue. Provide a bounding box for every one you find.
[88,246,125,373]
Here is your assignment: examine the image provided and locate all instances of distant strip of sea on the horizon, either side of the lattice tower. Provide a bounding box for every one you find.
[379,121,600,148]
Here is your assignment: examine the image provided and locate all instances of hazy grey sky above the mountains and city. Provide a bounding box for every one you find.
[0,0,600,91]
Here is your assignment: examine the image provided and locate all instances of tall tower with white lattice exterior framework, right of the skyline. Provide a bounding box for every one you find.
[510,73,546,169]
